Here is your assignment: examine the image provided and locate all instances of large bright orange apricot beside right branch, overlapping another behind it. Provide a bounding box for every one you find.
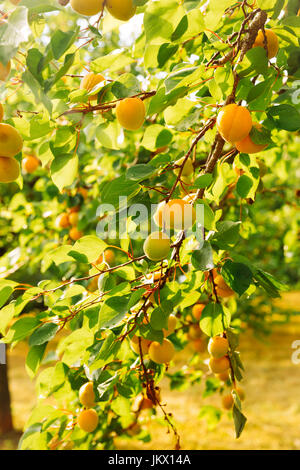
[217,103,252,143]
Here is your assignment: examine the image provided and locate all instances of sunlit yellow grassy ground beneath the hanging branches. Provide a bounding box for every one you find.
[0,292,300,450]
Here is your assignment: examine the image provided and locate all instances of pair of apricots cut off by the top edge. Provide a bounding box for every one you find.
[70,0,136,21]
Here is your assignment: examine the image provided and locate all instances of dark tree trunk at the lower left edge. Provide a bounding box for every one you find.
[0,344,13,435]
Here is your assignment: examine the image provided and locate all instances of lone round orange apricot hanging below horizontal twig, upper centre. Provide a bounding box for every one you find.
[116,98,146,131]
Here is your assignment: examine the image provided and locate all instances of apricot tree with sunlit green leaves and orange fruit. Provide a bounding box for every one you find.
[0,0,300,450]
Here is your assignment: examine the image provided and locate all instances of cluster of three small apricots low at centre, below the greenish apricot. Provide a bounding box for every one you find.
[130,315,177,364]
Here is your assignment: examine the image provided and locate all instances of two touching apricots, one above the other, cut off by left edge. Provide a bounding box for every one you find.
[0,104,23,183]
